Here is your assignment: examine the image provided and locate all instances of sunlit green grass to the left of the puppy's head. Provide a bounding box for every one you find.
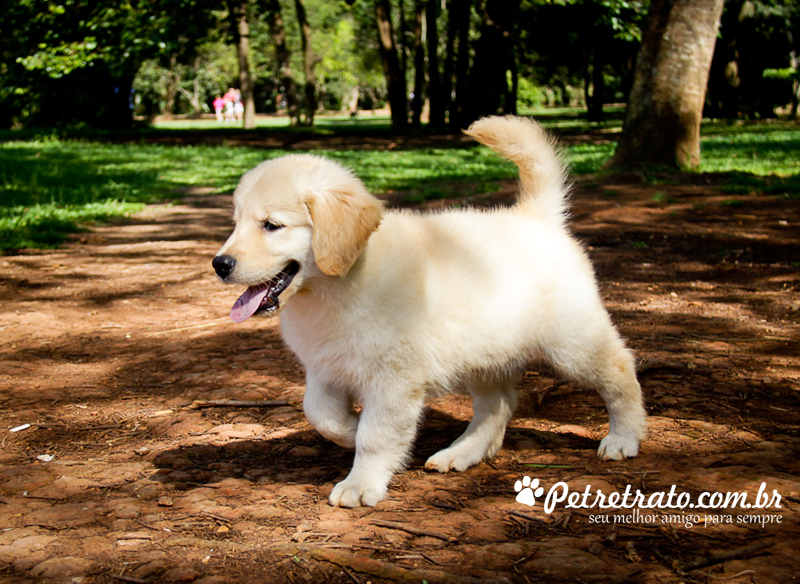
[0,137,272,250]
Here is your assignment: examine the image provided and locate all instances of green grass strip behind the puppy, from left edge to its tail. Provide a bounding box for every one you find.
[0,137,515,250]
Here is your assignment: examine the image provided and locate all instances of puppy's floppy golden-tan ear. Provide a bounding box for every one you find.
[306,180,383,276]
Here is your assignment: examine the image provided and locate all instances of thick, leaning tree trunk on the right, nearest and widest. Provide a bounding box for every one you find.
[609,0,723,168]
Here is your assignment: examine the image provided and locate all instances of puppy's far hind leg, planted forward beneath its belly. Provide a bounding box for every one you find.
[425,375,517,472]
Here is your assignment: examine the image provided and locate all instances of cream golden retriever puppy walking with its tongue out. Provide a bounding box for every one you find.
[213,117,645,507]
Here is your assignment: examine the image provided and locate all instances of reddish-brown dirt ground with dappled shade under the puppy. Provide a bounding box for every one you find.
[0,176,800,584]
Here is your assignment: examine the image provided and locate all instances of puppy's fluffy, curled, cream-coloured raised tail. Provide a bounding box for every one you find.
[465,116,568,224]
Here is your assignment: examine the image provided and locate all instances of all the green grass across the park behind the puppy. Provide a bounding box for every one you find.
[0,115,800,250]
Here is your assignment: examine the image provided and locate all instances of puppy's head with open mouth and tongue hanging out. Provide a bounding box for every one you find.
[212,154,383,322]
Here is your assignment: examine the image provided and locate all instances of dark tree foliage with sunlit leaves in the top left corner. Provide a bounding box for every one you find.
[0,0,215,128]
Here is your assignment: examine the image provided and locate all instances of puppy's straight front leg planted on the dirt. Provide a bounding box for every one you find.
[328,389,424,507]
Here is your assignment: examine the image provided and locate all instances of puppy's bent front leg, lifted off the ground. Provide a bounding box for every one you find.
[303,371,358,449]
